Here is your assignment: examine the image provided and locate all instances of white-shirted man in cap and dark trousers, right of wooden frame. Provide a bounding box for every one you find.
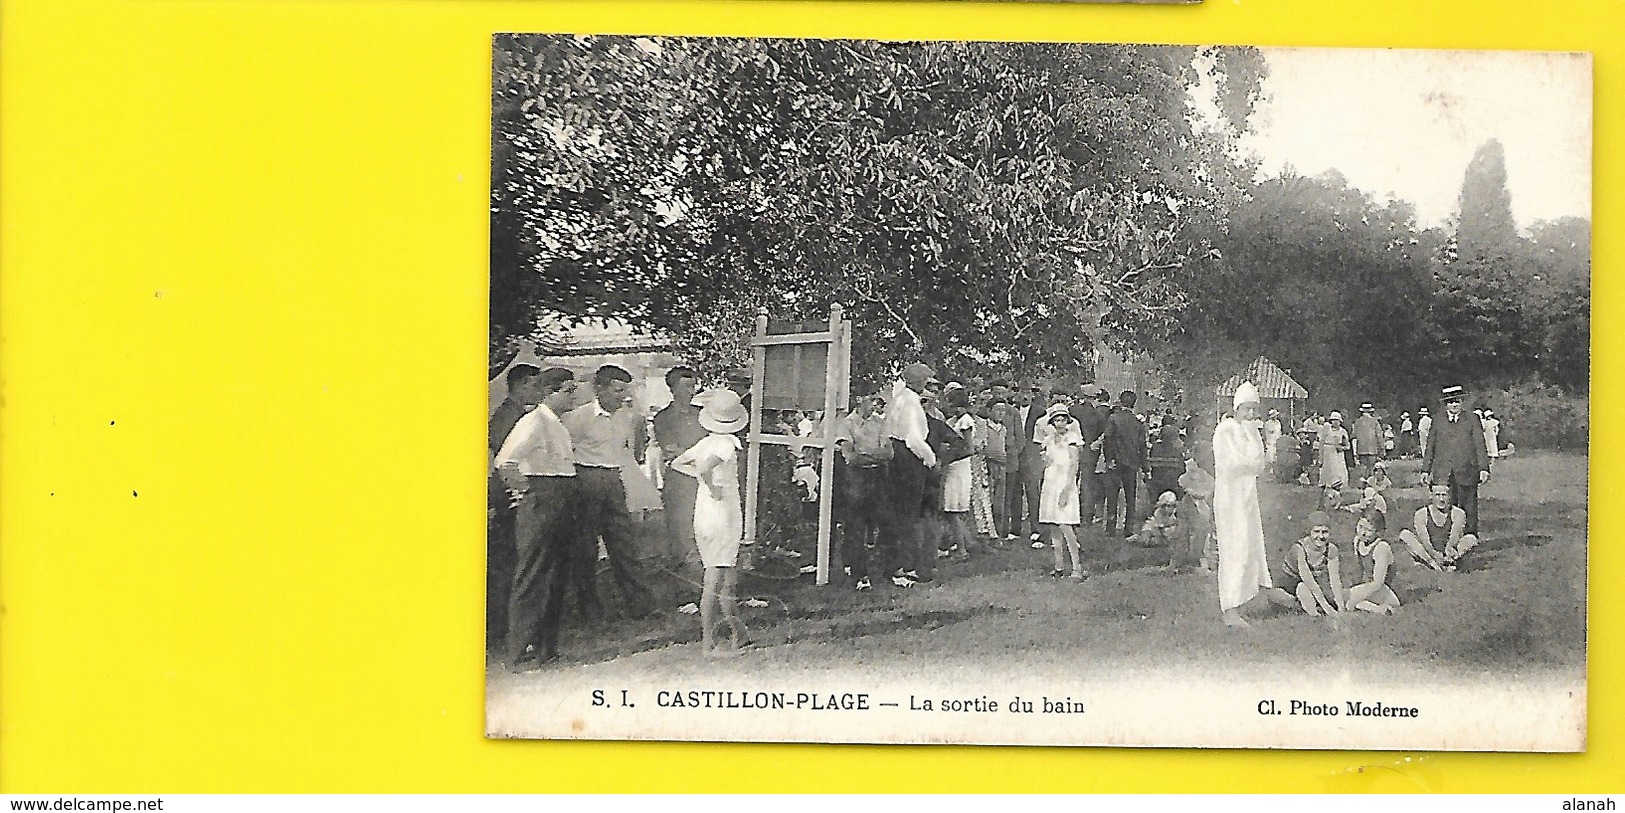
[886,361,936,587]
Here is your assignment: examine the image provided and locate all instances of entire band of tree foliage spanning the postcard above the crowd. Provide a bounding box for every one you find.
[491,36,1591,407]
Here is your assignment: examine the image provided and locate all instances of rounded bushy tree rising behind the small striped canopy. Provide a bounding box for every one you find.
[1167,172,1433,407]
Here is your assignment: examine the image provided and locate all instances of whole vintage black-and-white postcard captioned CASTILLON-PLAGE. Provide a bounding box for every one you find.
[484,34,1593,751]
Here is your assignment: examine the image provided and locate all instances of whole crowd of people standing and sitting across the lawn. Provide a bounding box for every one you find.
[489,356,1510,668]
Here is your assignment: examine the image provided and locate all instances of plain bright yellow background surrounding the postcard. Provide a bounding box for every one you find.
[0,0,1625,792]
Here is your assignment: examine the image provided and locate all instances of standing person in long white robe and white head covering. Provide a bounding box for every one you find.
[1214,380,1271,626]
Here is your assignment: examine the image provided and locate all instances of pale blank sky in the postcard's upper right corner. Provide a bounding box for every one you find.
[1243,49,1591,229]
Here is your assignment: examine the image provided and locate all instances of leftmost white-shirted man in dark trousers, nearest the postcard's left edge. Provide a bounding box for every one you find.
[496,367,598,668]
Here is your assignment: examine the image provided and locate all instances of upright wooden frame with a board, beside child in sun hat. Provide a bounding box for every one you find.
[744,304,852,585]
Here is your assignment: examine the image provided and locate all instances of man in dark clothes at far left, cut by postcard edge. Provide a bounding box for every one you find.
[486,364,541,655]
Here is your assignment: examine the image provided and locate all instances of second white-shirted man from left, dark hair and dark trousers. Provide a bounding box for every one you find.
[564,364,653,618]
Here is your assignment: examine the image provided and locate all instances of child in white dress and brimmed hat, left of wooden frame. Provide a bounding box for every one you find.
[671,390,749,657]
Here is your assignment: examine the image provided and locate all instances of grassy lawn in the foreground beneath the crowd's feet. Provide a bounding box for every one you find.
[494,452,1588,683]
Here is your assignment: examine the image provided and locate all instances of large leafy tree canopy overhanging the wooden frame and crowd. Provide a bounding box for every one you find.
[491,37,1264,382]
